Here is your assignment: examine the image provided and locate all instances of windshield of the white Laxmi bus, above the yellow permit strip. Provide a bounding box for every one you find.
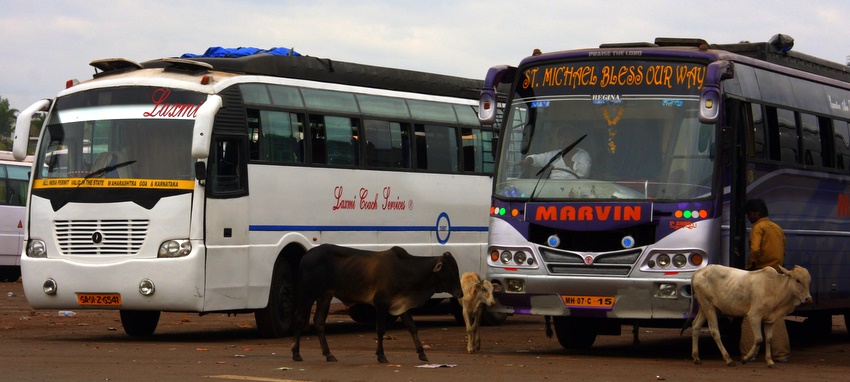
[36,88,204,186]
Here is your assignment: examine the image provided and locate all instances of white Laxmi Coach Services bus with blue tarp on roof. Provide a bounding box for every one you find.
[14,48,494,337]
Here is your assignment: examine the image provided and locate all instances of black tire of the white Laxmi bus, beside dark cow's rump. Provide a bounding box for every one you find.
[254,259,296,338]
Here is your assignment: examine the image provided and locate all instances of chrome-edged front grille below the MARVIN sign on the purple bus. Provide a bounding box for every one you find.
[540,247,641,276]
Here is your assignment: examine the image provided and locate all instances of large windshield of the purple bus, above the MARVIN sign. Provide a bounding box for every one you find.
[494,60,715,200]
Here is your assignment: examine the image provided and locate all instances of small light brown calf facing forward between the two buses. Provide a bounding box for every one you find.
[460,272,496,353]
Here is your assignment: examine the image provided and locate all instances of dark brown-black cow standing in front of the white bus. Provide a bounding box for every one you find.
[292,244,463,363]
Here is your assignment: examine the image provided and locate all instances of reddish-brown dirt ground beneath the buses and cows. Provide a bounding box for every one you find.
[0,282,850,382]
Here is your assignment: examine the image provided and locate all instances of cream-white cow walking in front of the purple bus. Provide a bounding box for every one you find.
[691,265,812,367]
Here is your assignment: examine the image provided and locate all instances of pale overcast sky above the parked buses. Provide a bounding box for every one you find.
[0,0,850,110]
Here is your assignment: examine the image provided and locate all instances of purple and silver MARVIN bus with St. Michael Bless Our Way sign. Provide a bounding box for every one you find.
[479,35,850,348]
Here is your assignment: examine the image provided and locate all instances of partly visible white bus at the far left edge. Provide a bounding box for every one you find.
[0,151,32,281]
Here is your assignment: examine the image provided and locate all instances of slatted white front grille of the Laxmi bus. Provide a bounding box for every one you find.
[54,220,150,255]
